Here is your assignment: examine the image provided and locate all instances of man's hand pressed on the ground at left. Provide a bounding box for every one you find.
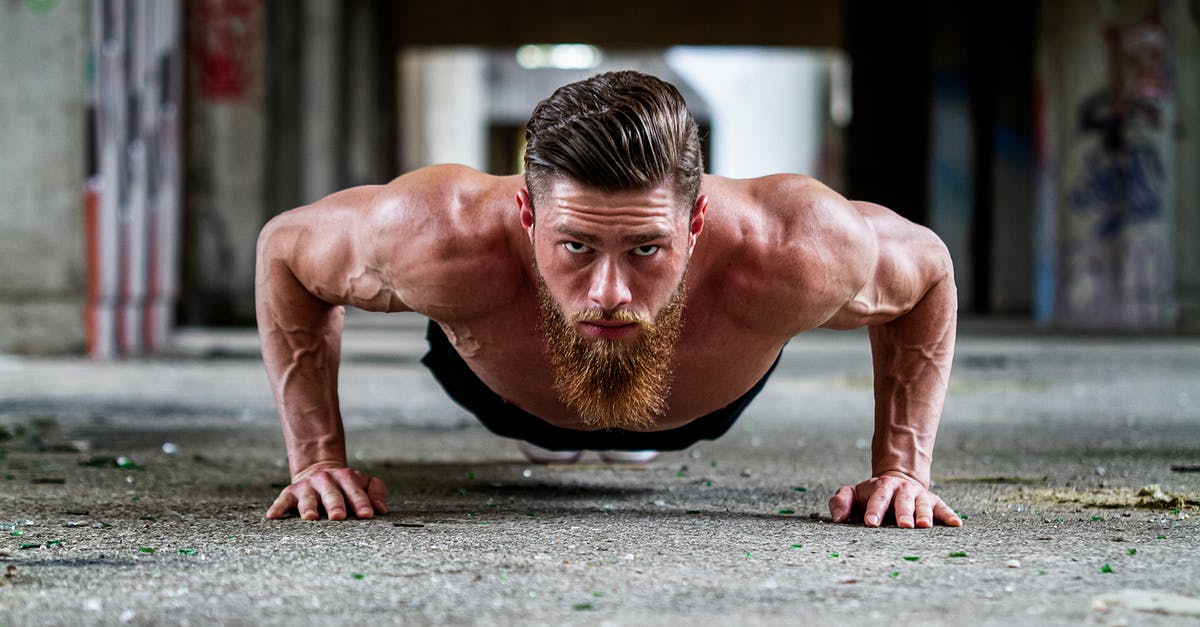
[266,467,388,520]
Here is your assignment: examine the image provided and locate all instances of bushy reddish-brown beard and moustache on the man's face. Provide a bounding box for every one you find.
[538,267,686,431]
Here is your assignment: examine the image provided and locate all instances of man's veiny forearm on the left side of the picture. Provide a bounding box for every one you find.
[254,233,347,478]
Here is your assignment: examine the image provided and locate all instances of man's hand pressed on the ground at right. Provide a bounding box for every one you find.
[829,472,962,529]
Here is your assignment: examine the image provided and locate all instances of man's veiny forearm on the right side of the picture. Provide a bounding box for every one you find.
[870,275,958,488]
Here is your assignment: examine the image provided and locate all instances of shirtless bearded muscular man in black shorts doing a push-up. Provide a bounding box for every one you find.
[256,72,961,527]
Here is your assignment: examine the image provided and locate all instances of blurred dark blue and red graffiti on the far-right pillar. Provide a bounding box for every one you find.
[1060,13,1172,329]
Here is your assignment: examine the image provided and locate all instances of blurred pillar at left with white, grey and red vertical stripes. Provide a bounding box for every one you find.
[84,0,182,359]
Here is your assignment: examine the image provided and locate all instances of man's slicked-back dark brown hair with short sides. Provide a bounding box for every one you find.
[524,71,704,211]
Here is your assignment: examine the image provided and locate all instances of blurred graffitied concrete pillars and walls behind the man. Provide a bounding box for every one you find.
[0,0,1200,359]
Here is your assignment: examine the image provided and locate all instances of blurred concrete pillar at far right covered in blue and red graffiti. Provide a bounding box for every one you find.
[1036,0,1194,330]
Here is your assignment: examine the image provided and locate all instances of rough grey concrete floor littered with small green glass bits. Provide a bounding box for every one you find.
[0,316,1200,626]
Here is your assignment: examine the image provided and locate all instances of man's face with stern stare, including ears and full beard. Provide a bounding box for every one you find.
[517,180,706,430]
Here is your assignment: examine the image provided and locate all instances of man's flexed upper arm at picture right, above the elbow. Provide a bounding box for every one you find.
[822,202,953,329]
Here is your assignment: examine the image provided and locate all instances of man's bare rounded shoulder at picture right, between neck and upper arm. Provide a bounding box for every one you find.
[706,174,877,335]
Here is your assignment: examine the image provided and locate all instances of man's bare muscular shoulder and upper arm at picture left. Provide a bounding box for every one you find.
[259,166,521,320]
